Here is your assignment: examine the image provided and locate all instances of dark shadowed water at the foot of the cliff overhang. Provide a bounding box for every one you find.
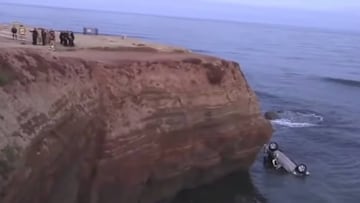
[170,172,267,203]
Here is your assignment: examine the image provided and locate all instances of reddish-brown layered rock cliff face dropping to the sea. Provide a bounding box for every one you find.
[0,48,272,203]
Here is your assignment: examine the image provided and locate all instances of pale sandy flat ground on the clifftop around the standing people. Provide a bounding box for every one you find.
[0,24,189,52]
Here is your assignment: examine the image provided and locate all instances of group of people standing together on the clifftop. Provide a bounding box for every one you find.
[11,25,75,49]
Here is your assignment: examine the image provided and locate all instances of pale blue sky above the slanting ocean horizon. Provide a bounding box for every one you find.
[0,0,360,30]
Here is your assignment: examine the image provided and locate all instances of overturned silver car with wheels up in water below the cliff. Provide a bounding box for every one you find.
[264,142,310,176]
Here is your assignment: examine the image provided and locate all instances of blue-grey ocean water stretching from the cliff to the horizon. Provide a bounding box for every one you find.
[0,4,360,203]
